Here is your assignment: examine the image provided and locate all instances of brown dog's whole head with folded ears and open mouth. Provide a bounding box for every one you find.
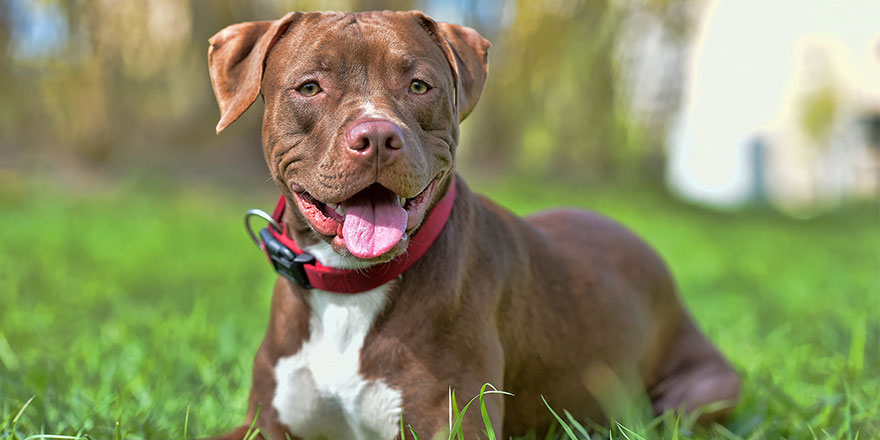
[208,12,489,262]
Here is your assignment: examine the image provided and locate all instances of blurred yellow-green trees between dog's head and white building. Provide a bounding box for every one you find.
[460,0,694,178]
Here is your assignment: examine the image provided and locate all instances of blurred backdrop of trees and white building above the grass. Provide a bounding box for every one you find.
[0,0,880,211]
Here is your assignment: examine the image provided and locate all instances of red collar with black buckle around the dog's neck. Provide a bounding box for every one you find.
[261,176,455,293]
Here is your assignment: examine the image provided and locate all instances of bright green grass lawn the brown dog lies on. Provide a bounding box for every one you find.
[0,174,880,440]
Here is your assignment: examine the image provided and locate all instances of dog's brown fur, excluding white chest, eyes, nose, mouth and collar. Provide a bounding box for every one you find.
[203,12,739,440]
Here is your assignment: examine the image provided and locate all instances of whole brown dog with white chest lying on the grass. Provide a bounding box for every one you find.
[203,12,739,440]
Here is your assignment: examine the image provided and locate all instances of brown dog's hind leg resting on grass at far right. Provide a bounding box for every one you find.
[650,316,740,425]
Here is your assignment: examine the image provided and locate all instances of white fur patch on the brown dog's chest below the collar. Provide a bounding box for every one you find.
[272,242,402,440]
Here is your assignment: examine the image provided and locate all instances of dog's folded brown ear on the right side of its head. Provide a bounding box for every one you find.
[417,12,491,122]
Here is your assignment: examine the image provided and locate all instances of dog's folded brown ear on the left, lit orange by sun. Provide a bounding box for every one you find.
[208,12,301,133]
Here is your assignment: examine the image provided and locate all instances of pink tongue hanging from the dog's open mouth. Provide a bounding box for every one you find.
[342,185,406,258]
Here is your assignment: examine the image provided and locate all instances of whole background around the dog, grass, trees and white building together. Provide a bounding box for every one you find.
[0,0,880,439]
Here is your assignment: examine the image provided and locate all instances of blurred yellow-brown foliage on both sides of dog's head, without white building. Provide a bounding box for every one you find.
[0,0,695,180]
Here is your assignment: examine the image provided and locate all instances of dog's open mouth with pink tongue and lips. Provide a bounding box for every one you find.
[293,176,439,259]
